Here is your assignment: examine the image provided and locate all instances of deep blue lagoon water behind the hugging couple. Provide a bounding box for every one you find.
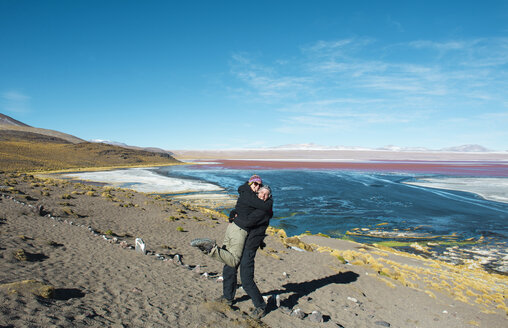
[154,165,508,271]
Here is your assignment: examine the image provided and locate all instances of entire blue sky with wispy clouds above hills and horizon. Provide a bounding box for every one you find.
[0,0,508,150]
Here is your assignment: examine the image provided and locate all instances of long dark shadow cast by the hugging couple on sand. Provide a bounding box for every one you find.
[237,271,359,308]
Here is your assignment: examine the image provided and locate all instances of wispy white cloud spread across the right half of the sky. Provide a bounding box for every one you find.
[231,38,508,144]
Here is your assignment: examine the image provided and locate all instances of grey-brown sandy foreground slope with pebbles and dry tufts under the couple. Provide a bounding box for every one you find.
[0,175,508,328]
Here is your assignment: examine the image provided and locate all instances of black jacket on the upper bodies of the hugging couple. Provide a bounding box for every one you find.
[230,182,273,234]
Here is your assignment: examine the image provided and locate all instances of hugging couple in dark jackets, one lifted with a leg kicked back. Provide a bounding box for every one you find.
[191,175,273,319]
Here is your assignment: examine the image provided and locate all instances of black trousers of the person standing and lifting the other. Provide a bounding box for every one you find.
[222,245,266,307]
